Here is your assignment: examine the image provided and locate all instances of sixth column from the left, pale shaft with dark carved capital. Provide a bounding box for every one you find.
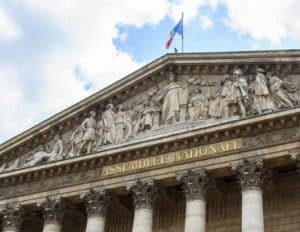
[236,159,267,232]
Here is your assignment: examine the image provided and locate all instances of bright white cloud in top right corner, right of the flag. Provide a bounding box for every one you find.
[222,0,300,45]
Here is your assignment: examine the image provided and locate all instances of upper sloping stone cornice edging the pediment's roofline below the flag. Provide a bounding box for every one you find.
[0,50,300,165]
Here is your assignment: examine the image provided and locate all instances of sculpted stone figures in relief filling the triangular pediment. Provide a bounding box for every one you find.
[0,65,299,172]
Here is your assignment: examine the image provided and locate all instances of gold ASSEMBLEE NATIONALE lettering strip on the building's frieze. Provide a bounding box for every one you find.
[102,139,243,177]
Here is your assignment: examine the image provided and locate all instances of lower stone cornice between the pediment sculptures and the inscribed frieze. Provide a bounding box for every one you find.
[0,108,300,187]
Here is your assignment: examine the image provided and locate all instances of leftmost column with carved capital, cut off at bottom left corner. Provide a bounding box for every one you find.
[2,204,24,232]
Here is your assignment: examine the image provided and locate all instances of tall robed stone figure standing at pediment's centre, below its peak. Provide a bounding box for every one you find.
[161,72,182,124]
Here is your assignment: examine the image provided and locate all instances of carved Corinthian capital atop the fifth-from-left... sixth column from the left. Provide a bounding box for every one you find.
[236,158,270,191]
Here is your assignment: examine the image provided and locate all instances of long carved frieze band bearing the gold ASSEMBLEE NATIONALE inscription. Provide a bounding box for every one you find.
[0,125,300,199]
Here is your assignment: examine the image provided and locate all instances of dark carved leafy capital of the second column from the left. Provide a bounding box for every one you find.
[38,197,65,224]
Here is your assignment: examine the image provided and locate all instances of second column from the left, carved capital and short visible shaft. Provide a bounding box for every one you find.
[38,197,65,232]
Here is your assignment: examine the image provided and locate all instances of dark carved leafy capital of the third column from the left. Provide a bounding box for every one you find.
[81,188,112,216]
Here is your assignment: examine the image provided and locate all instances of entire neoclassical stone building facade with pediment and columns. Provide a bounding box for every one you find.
[0,50,300,232]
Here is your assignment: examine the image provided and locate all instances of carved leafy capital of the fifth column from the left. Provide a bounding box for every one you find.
[177,169,208,200]
